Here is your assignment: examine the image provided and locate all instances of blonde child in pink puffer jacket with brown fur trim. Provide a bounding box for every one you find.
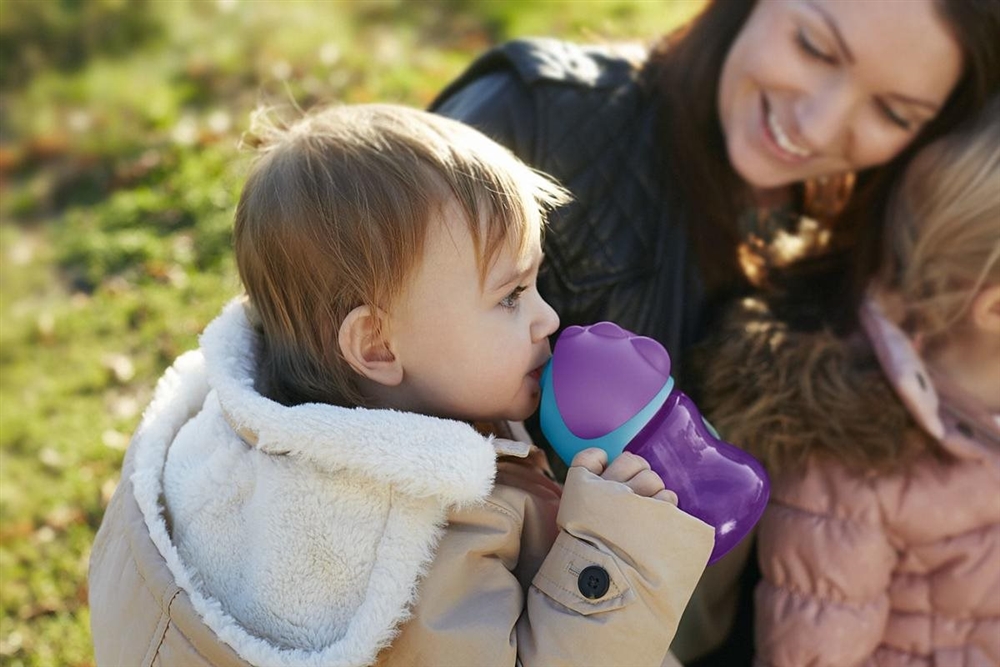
[705,100,1000,667]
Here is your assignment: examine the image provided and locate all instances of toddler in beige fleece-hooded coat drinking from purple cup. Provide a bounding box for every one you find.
[90,105,713,667]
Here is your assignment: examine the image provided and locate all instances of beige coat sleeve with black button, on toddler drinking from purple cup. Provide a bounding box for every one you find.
[383,468,714,667]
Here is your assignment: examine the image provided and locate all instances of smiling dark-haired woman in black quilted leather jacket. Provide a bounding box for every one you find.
[432,0,1000,665]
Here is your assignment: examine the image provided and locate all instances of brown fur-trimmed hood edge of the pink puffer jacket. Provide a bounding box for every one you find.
[694,299,996,474]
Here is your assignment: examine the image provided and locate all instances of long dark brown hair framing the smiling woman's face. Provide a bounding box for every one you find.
[643,0,1000,325]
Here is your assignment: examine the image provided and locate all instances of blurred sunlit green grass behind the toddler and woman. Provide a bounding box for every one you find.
[0,0,700,666]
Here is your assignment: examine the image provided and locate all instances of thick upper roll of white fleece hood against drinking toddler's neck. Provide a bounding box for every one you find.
[200,300,496,504]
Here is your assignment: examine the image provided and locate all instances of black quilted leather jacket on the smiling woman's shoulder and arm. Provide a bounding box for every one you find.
[431,39,705,369]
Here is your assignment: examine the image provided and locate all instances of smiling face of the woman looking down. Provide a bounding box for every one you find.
[718,0,962,189]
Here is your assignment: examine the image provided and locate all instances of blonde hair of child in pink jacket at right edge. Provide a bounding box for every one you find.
[880,97,1000,344]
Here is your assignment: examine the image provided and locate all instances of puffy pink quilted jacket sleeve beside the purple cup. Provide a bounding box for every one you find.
[754,466,897,667]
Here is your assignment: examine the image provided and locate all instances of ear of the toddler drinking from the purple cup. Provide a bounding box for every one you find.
[339,306,403,387]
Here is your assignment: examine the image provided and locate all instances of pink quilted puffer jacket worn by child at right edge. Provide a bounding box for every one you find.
[755,303,1000,667]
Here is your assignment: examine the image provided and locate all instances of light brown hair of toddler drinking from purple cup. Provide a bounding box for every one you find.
[234,105,567,406]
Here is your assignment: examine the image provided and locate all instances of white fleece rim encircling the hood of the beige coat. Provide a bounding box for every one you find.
[131,300,508,667]
